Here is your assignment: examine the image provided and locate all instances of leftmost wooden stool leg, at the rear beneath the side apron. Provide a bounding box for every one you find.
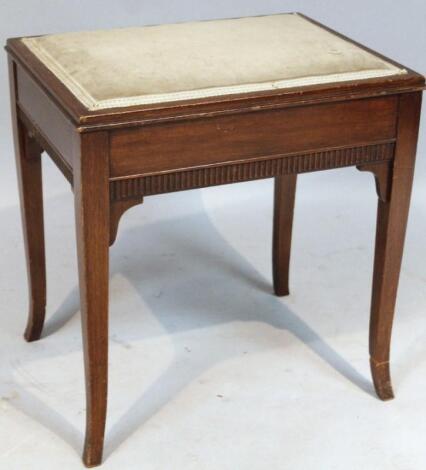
[9,61,46,341]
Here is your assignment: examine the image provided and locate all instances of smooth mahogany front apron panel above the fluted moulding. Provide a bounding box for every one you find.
[111,96,398,177]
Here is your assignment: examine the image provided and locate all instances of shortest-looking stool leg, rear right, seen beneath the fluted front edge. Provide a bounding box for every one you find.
[272,175,297,296]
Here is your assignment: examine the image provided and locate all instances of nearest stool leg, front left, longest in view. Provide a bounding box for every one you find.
[74,132,109,467]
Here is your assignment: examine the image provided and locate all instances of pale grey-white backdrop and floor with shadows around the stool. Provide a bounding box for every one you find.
[0,0,426,470]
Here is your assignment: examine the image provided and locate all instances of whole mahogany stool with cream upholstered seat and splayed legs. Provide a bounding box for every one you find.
[6,14,425,466]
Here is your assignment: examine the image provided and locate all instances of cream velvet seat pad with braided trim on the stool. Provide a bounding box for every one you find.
[22,14,405,110]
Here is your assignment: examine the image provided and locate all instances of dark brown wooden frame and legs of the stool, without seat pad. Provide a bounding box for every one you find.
[6,17,425,466]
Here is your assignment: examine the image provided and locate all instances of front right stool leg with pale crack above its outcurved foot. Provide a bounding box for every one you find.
[370,93,421,400]
